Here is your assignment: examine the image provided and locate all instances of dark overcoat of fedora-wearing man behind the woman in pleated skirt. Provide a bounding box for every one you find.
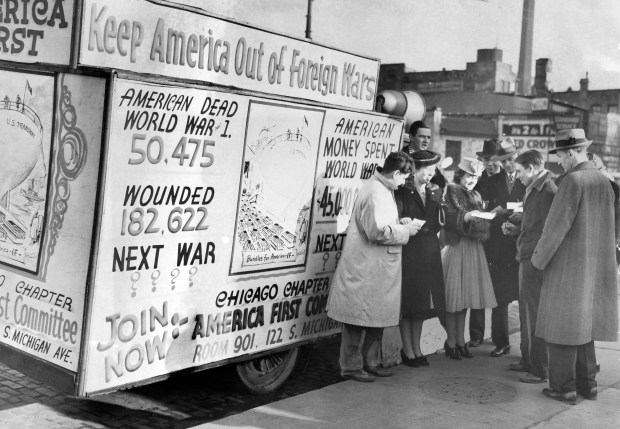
[484,169,525,305]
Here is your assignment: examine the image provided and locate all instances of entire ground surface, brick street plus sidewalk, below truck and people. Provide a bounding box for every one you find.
[0,304,620,429]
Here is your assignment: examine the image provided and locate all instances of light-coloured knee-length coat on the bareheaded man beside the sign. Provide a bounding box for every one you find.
[327,172,409,328]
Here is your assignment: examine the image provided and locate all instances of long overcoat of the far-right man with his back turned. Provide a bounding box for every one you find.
[531,162,618,346]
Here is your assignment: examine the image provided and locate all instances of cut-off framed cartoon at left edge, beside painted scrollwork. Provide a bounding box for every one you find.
[0,73,53,272]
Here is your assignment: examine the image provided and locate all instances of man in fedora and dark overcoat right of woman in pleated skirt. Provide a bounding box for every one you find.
[470,137,525,357]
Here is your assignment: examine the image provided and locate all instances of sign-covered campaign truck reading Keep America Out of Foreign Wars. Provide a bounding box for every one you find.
[0,0,422,397]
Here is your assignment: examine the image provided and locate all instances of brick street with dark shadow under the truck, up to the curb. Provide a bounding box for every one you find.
[0,337,342,429]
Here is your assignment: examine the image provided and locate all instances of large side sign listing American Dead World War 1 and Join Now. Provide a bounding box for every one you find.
[84,78,403,393]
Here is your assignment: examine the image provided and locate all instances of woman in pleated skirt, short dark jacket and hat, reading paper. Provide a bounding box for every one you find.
[441,158,497,360]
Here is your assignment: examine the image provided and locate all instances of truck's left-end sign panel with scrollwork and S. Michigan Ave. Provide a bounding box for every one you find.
[0,71,105,371]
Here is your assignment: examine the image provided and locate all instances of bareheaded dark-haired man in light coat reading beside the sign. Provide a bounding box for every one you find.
[327,152,420,381]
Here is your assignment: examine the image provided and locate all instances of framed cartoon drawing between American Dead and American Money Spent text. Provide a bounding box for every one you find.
[231,102,324,274]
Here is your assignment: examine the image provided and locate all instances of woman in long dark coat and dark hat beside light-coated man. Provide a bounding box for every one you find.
[394,150,446,367]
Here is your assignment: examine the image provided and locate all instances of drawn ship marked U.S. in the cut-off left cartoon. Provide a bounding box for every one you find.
[0,89,44,246]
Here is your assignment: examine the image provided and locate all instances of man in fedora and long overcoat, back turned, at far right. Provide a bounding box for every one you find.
[531,129,618,404]
